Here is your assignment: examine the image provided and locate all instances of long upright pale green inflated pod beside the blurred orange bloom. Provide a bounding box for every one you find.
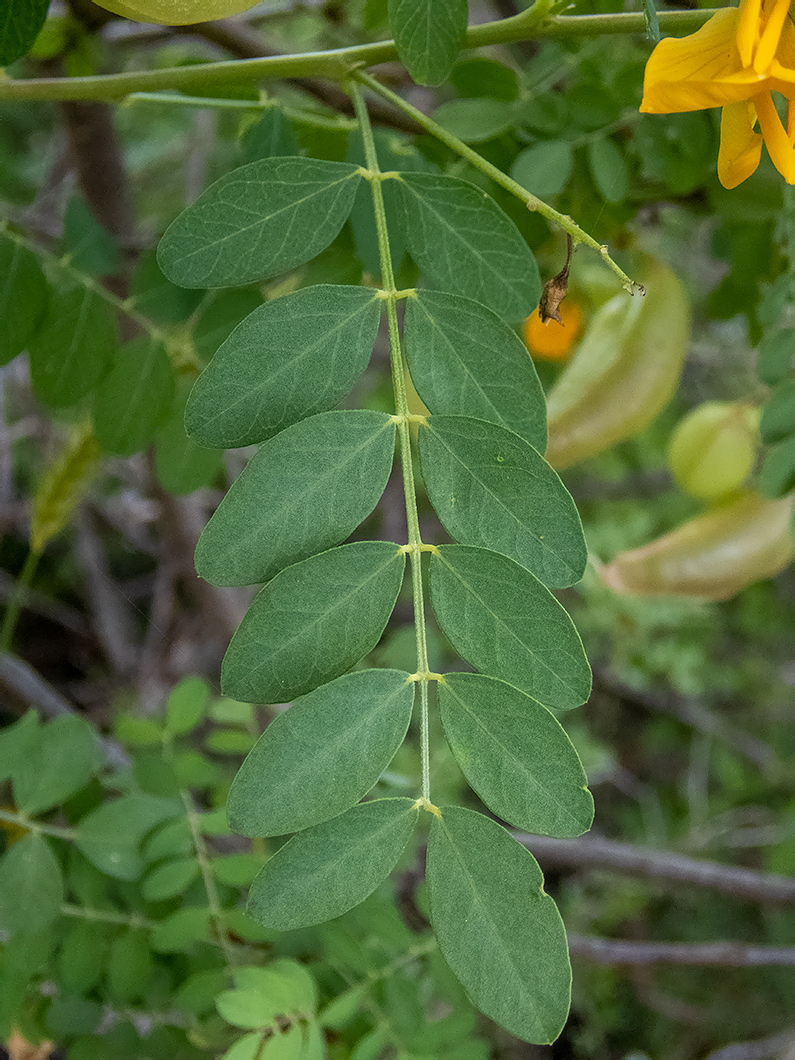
[546,262,690,469]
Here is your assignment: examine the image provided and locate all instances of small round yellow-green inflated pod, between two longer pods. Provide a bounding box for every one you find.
[668,401,759,501]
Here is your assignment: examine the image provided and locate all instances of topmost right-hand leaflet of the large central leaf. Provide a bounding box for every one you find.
[398,173,541,323]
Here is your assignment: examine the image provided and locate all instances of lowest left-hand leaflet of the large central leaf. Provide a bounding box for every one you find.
[247,798,419,931]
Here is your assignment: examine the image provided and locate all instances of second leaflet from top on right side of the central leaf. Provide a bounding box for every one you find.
[403,288,547,453]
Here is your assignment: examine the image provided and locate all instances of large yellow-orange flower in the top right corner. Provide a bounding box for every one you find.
[640,0,795,188]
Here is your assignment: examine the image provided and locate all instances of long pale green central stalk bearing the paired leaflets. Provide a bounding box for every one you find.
[349,83,430,799]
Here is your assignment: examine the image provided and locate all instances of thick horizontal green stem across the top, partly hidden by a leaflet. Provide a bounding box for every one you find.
[0,4,716,102]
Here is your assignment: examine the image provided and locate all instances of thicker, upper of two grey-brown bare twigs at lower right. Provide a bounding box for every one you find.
[514,833,795,904]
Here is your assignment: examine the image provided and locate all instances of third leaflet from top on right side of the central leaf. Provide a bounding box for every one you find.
[419,416,587,588]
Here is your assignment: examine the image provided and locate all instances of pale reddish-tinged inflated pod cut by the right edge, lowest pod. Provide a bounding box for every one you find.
[599,490,793,600]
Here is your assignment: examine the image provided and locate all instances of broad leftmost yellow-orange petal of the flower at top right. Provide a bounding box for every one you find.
[640,7,762,114]
